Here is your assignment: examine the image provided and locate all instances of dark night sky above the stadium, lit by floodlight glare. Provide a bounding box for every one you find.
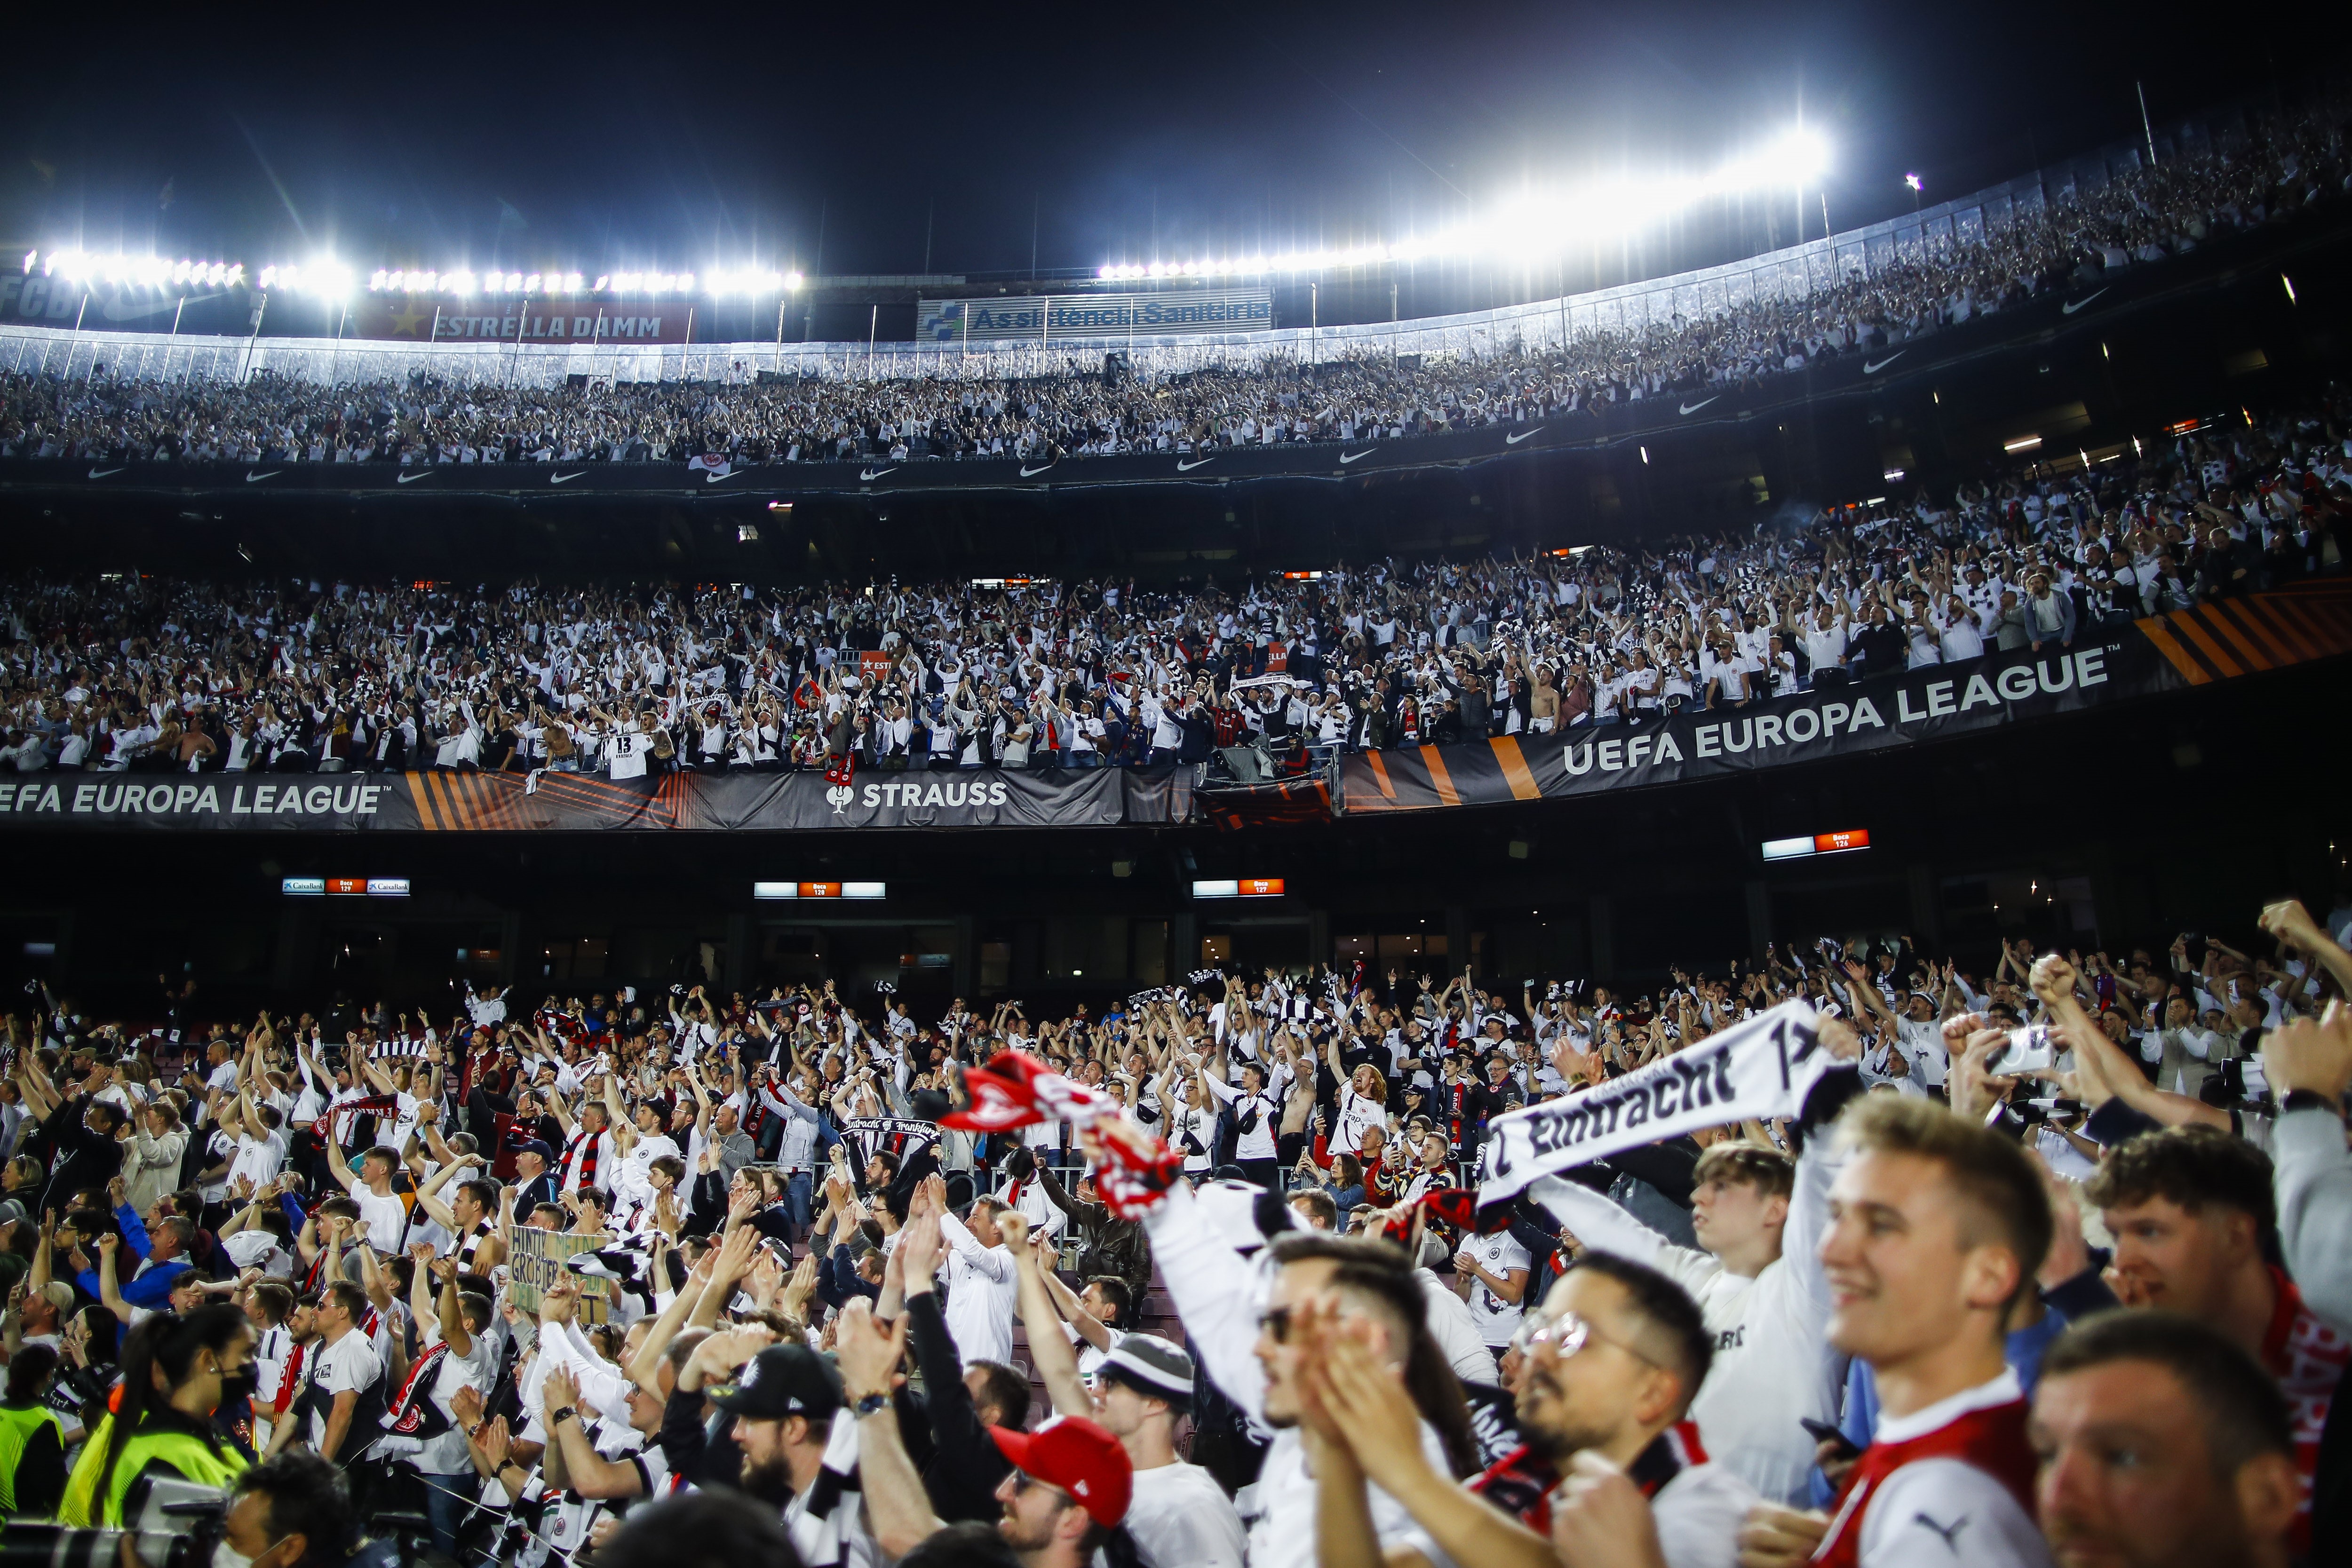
[0,0,2345,291]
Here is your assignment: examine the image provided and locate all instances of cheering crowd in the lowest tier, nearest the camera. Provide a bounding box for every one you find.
[0,898,2352,1568]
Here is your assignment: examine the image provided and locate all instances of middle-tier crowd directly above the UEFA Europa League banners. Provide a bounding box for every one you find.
[0,395,2352,778]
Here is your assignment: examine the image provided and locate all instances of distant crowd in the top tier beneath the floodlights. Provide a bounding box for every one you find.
[0,111,2352,465]
